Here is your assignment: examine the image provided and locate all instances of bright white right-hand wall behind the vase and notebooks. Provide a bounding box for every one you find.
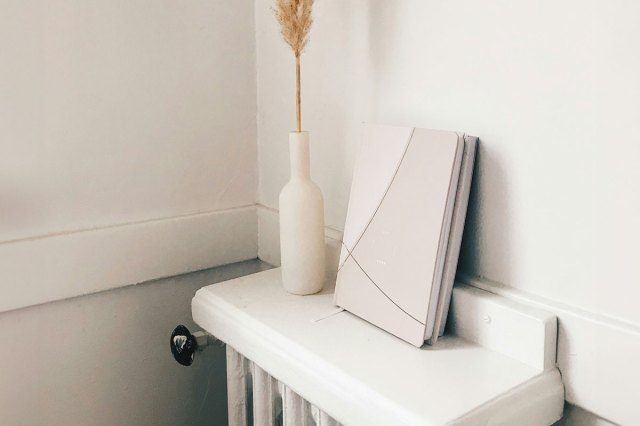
[256,0,640,418]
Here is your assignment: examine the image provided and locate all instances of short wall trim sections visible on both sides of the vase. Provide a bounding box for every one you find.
[258,204,342,278]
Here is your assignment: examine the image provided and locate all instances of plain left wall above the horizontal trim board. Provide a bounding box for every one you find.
[0,0,256,241]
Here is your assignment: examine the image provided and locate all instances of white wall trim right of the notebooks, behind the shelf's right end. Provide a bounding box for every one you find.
[457,273,640,425]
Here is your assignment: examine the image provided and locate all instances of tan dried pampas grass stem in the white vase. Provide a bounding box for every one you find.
[275,0,313,132]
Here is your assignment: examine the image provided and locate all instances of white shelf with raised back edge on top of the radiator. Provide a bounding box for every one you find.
[192,269,564,426]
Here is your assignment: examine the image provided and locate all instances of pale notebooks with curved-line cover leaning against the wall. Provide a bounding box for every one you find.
[335,125,477,347]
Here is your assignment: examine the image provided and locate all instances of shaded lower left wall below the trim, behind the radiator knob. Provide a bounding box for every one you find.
[0,261,265,426]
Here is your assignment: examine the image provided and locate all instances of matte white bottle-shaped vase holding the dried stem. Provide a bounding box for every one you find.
[280,132,325,295]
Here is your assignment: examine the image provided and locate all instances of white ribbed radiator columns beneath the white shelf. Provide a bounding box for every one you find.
[227,345,339,426]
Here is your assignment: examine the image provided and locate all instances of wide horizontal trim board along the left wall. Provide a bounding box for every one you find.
[0,206,258,312]
